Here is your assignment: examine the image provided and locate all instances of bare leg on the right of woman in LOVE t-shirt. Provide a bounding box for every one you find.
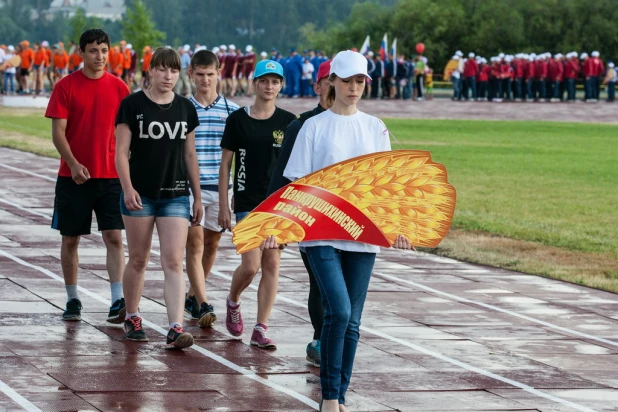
[155,217,188,325]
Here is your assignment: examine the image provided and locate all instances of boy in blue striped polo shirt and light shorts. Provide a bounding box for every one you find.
[185,50,238,327]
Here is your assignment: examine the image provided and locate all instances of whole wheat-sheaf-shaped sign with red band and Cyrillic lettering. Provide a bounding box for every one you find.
[232,150,456,253]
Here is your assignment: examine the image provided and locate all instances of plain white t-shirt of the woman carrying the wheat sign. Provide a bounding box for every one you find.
[283,110,391,253]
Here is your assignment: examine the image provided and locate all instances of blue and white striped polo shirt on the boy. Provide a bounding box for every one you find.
[189,96,239,185]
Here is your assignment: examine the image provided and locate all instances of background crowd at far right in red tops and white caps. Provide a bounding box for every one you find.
[444,50,618,102]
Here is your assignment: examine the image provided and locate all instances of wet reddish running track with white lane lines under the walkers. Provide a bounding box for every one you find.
[0,149,618,411]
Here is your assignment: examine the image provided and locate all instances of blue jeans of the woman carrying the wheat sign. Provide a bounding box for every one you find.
[306,246,376,404]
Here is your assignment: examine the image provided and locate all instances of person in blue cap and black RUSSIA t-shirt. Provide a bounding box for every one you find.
[219,60,296,349]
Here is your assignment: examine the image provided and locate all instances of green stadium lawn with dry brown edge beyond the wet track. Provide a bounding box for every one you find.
[0,109,618,292]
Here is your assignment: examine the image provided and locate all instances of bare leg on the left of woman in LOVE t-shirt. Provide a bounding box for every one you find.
[122,216,154,314]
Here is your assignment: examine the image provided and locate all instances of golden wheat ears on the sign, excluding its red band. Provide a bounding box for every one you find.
[233,150,456,253]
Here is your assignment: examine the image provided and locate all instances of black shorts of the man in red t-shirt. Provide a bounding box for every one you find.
[52,176,124,236]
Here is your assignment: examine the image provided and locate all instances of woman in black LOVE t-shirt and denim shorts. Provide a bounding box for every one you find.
[116,48,203,349]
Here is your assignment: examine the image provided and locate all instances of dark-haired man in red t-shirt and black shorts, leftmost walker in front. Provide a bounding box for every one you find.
[45,29,129,323]
